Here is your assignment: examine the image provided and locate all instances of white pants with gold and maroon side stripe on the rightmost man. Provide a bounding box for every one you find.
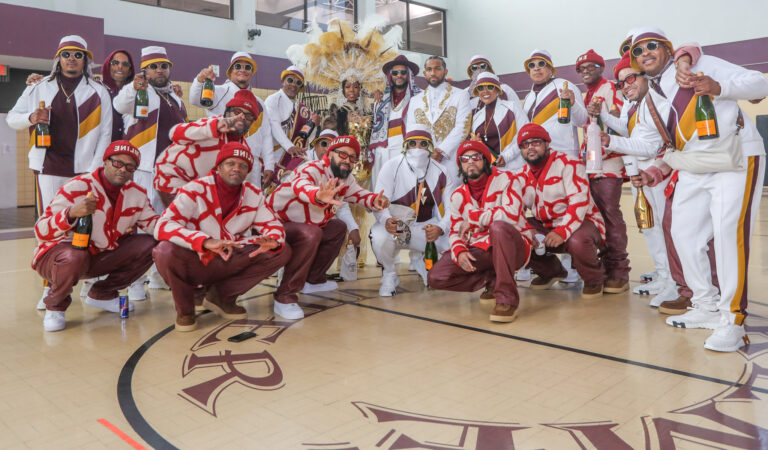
[670,156,765,325]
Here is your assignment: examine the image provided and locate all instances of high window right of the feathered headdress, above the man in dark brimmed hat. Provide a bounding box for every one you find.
[376,0,445,56]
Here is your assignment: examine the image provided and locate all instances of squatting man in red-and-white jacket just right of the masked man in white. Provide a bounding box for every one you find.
[427,141,534,322]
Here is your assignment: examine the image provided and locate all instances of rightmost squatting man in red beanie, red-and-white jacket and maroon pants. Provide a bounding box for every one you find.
[517,123,605,298]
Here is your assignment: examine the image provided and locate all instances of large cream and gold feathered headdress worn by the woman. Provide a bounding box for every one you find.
[286,14,403,96]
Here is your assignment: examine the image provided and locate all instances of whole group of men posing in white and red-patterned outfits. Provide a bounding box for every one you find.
[8,27,768,351]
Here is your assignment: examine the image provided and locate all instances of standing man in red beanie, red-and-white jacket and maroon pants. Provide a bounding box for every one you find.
[576,49,629,293]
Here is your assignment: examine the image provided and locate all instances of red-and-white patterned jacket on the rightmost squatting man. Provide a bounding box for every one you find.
[518,150,605,240]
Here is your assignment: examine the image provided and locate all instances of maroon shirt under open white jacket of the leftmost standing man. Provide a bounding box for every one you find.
[41,75,83,178]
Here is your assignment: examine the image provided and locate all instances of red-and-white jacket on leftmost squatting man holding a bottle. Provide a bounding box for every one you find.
[32,169,158,268]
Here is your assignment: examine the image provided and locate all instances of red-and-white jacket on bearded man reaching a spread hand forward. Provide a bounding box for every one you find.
[267,158,376,227]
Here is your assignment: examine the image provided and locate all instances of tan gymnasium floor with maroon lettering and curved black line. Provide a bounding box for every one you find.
[0,194,768,450]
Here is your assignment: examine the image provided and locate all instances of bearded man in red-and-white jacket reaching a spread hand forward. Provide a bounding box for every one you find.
[267,136,389,320]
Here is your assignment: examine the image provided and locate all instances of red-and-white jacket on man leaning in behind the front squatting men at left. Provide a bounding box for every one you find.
[153,116,250,194]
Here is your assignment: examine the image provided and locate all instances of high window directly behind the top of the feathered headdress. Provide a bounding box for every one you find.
[256,0,356,31]
